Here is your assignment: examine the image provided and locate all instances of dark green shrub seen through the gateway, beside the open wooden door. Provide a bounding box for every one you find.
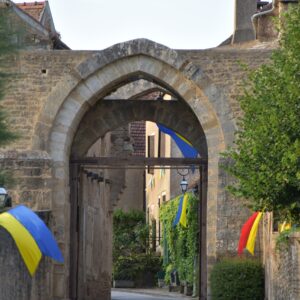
[113,209,161,287]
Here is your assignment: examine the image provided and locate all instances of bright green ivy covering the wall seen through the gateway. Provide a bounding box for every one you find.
[160,193,199,284]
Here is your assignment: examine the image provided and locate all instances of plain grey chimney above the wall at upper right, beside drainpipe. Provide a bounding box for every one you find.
[232,0,257,43]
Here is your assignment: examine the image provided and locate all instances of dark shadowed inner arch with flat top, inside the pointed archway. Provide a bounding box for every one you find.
[71,100,207,157]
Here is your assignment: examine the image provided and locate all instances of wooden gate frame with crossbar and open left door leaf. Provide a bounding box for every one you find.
[70,157,207,300]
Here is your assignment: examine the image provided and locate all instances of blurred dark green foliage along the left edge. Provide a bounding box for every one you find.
[0,7,17,185]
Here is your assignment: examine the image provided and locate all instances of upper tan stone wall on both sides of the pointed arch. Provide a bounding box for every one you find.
[2,49,270,150]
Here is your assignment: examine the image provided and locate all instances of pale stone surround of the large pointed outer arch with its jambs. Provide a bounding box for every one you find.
[34,40,235,298]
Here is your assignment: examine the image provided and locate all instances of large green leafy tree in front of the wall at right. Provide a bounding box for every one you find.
[225,4,300,223]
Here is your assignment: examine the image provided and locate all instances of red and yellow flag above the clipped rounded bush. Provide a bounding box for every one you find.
[238,212,262,255]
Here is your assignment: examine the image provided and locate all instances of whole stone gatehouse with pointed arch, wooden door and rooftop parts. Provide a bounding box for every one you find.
[0,0,299,300]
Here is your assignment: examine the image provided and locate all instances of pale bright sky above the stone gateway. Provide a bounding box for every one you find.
[14,0,235,50]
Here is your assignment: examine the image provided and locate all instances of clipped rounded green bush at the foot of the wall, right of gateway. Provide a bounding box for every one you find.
[210,259,264,300]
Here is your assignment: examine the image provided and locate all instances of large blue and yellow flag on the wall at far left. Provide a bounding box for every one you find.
[0,205,64,276]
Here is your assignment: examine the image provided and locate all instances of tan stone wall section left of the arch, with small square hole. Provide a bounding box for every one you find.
[1,50,89,151]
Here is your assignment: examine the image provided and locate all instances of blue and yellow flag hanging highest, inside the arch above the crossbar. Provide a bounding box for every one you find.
[157,124,199,158]
